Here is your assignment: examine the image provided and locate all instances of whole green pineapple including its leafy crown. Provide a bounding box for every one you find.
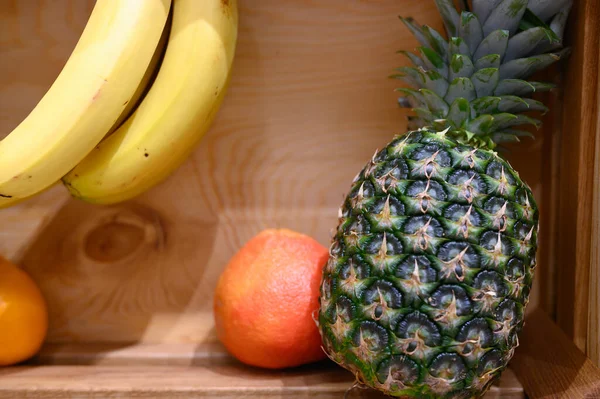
[318,0,571,398]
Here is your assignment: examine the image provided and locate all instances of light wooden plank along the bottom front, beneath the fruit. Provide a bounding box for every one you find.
[0,362,525,399]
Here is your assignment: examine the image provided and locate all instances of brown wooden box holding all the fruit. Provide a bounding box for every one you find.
[0,0,600,399]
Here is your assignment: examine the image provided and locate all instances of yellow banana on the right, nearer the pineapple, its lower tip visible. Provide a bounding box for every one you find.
[63,0,238,204]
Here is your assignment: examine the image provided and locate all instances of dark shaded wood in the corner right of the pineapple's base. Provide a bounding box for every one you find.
[510,310,600,399]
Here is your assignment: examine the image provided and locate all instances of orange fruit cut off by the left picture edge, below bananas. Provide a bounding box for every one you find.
[0,256,48,366]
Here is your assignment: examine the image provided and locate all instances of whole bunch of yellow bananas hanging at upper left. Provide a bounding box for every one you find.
[0,0,238,208]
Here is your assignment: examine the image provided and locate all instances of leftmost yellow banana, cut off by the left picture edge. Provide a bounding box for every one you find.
[0,0,171,208]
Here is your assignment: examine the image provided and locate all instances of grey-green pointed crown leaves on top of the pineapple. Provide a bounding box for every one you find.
[391,0,572,149]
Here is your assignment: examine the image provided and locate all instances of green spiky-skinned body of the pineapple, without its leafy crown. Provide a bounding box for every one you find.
[318,129,538,398]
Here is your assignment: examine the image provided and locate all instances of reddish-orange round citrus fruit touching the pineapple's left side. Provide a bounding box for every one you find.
[214,229,328,369]
